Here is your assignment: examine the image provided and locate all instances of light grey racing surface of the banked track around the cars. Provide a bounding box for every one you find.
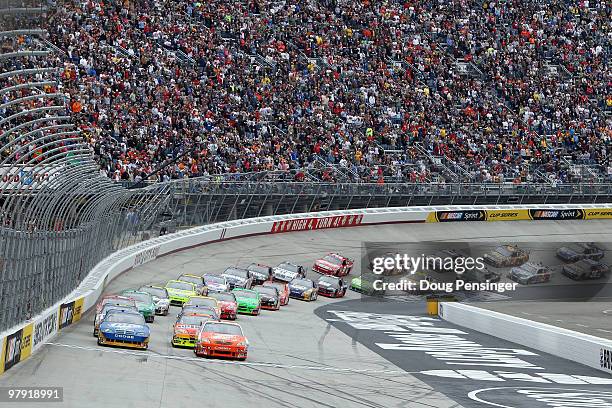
[0,221,611,408]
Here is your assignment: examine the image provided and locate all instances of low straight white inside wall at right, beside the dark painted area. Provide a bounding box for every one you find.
[438,302,612,374]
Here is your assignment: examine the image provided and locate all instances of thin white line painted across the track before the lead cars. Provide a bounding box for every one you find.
[45,343,420,375]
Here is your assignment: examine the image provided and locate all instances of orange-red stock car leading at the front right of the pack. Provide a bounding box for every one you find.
[193,322,249,361]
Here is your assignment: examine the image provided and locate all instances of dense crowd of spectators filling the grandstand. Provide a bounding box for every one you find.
[1,0,612,183]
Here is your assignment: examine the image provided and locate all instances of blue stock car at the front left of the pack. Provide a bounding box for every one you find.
[98,310,151,350]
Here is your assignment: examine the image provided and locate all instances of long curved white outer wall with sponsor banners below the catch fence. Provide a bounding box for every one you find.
[0,205,612,374]
